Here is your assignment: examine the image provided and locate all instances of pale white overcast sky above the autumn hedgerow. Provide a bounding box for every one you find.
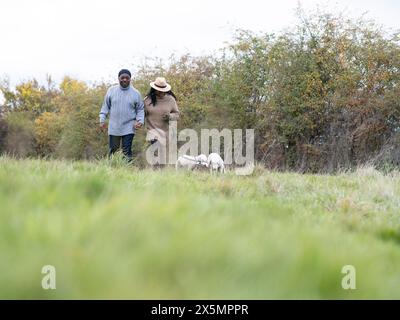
[0,0,400,84]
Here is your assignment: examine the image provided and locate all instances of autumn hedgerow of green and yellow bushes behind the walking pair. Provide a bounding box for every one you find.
[0,11,400,172]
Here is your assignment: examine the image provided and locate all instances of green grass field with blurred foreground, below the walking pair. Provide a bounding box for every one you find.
[0,157,400,299]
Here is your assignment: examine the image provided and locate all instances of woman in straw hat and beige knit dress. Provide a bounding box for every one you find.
[144,77,179,165]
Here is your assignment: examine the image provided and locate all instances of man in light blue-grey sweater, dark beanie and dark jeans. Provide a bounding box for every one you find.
[100,69,144,162]
